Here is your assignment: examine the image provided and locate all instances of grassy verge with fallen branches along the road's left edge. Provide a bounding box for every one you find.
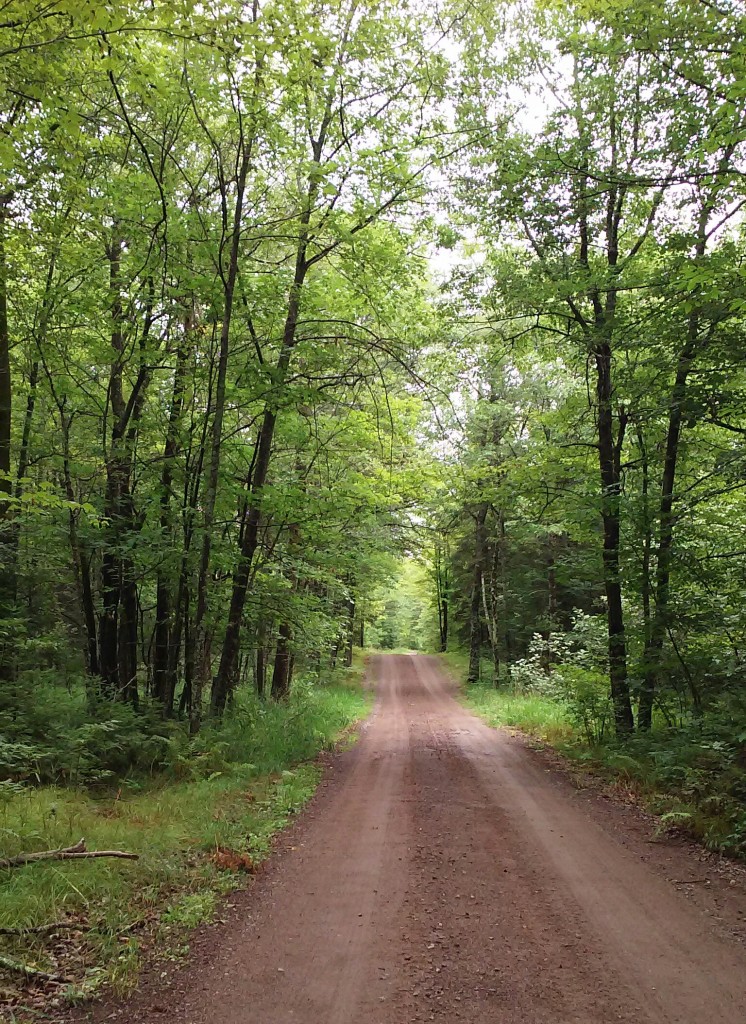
[0,657,369,1006]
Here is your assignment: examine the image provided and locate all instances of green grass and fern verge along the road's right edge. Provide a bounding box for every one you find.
[441,651,746,858]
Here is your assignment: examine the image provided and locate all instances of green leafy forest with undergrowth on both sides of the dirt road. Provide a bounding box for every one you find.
[0,0,746,997]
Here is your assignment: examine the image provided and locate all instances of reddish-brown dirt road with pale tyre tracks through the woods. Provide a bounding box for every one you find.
[84,655,746,1024]
